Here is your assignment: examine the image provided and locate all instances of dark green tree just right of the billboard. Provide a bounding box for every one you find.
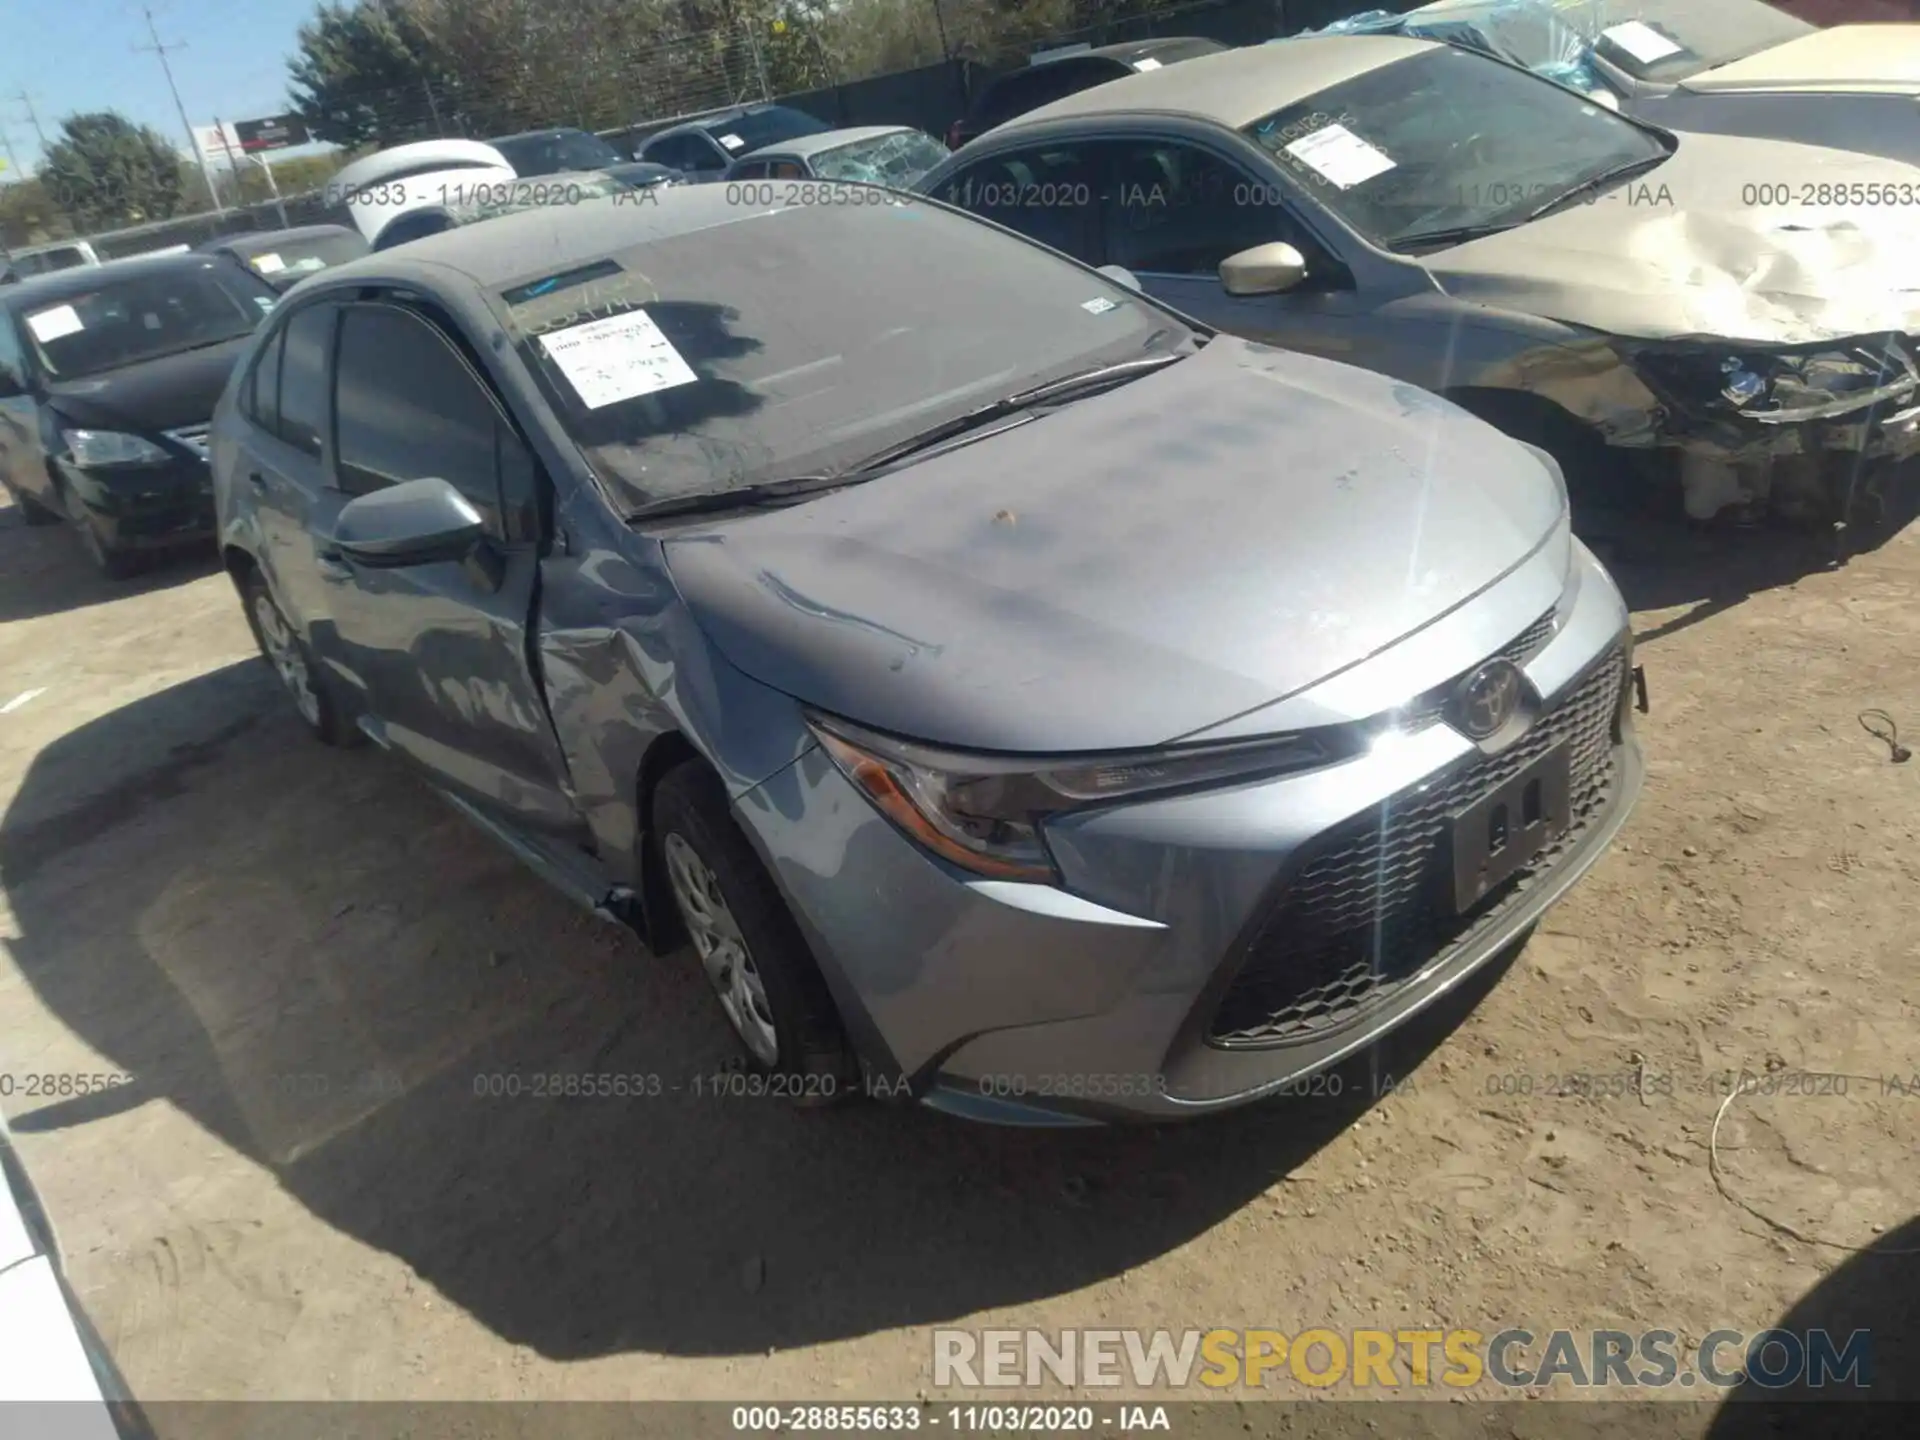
[288,0,451,150]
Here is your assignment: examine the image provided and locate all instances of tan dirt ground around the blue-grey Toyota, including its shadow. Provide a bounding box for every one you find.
[0,495,1920,1427]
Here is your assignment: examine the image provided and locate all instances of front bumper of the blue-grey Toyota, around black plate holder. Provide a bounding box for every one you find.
[741,553,1642,1123]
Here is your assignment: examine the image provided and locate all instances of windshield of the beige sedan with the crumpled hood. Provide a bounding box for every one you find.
[1246,48,1667,250]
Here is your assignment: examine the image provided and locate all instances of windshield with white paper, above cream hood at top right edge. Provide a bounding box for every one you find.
[1553,0,1816,84]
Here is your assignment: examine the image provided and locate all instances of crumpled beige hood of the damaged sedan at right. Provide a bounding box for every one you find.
[1419,134,1920,344]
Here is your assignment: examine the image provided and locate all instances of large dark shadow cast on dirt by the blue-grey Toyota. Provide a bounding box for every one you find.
[0,660,1511,1357]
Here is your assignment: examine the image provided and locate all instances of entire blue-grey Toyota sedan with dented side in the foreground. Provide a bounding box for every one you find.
[213,182,1640,1121]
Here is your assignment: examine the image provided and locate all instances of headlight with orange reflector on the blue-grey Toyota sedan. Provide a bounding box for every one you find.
[806,714,1336,881]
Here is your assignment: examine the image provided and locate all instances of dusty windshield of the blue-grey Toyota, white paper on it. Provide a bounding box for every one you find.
[499,192,1192,509]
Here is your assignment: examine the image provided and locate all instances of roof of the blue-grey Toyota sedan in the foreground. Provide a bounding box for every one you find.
[307,184,810,292]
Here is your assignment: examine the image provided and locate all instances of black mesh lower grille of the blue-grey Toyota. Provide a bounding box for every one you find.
[1208,647,1626,1046]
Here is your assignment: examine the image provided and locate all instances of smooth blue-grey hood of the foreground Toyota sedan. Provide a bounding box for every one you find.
[664,336,1563,753]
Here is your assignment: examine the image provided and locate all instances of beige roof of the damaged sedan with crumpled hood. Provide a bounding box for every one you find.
[996,35,1446,132]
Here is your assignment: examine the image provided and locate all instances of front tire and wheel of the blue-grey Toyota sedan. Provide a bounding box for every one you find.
[653,760,860,1104]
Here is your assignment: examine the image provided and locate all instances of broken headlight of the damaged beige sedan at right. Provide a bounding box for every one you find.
[1620,334,1920,424]
